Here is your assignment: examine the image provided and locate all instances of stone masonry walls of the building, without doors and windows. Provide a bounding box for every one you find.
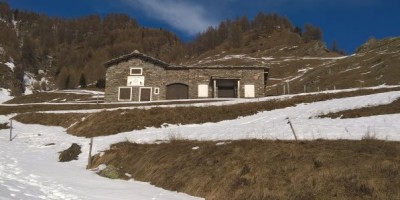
[105,58,265,102]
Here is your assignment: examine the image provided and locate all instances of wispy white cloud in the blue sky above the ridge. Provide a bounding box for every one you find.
[123,0,217,35]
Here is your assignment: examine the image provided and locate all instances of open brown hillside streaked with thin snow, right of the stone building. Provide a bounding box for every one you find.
[187,34,400,95]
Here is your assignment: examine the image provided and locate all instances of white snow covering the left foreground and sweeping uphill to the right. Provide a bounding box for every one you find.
[0,88,400,200]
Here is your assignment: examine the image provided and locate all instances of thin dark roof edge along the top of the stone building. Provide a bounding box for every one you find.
[104,50,269,70]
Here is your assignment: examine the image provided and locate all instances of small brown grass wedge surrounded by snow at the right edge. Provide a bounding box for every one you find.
[319,99,400,118]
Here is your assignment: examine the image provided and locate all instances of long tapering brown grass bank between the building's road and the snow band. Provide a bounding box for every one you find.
[67,89,398,137]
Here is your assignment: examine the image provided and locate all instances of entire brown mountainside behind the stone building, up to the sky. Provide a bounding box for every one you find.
[0,3,400,95]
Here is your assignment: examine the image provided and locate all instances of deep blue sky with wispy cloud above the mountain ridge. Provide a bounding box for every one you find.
[6,0,400,53]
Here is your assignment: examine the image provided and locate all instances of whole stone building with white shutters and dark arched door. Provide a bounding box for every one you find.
[105,51,269,102]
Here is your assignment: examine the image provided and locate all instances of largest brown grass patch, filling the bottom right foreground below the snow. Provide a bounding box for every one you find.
[93,140,400,200]
